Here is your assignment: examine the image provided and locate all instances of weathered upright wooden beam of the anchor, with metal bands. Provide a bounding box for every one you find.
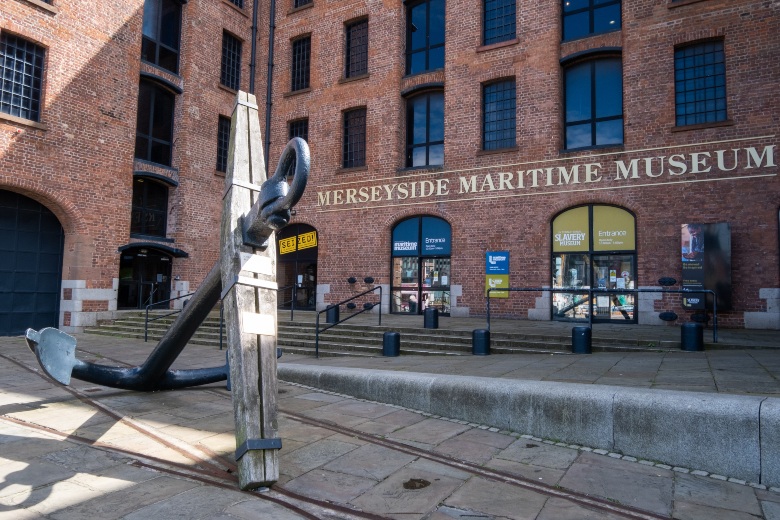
[220,92,281,489]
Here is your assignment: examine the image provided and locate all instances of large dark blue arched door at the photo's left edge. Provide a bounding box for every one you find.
[0,190,65,336]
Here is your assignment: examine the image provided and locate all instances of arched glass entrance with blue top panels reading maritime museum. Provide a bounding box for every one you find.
[390,216,452,316]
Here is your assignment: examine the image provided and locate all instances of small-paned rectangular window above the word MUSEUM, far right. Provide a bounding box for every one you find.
[674,41,726,126]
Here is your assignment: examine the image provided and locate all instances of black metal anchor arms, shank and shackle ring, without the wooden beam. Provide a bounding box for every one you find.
[25,137,310,391]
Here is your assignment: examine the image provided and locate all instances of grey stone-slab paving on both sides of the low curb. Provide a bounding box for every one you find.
[0,335,780,520]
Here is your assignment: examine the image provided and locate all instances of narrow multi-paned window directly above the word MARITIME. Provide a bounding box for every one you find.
[482,79,516,150]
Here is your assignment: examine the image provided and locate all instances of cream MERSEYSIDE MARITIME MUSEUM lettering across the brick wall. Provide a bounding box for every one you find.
[317,138,777,209]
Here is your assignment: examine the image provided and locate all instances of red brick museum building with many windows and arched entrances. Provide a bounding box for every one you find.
[0,0,780,334]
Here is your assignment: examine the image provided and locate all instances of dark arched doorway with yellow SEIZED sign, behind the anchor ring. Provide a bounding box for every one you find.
[276,224,318,310]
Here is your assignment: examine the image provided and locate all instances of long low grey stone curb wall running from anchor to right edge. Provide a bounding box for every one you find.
[278,363,780,487]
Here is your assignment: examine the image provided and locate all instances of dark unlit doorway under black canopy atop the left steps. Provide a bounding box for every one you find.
[117,247,172,309]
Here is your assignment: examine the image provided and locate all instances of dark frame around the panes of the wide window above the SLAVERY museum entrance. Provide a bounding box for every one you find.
[563,54,625,151]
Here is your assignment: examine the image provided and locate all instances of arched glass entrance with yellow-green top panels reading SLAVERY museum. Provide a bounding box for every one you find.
[552,204,637,323]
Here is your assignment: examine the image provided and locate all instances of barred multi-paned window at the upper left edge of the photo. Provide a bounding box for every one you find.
[0,33,44,121]
